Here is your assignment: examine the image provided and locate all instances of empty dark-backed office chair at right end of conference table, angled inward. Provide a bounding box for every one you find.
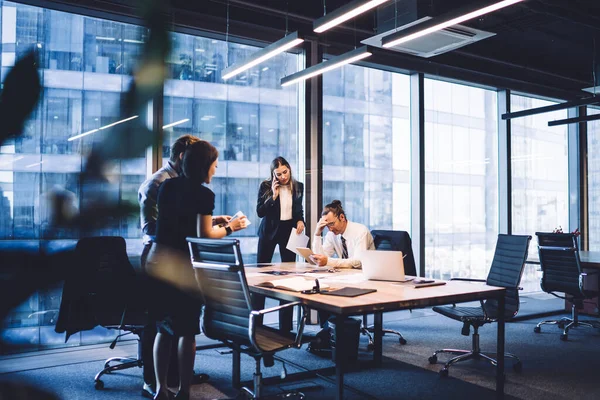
[429,234,531,377]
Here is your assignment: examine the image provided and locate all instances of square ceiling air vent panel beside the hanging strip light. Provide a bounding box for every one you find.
[362,17,495,58]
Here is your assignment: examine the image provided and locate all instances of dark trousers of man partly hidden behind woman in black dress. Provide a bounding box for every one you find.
[140,243,179,386]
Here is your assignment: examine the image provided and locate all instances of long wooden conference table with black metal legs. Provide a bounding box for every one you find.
[245,262,505,399]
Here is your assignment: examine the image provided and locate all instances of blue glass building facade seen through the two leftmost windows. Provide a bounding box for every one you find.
[0,1,304,349]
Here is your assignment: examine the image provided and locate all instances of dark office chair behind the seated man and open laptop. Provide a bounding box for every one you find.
[361,230,417,351]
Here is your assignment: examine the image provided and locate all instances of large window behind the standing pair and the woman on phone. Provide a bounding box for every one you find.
[163,33,304,263]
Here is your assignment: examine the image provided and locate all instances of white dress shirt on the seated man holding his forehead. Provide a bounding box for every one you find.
[312,221,375,268]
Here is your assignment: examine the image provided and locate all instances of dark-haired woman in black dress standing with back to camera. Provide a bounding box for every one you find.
[148,140,247,400]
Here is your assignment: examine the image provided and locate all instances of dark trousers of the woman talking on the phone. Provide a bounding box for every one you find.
[252,220,296,332]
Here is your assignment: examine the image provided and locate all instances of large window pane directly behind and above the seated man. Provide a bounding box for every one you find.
[316,65,411,232]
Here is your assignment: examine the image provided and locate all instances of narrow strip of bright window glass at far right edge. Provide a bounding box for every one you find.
[587,107,600,251]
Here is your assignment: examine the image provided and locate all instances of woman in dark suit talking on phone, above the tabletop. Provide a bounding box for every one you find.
[256,157,304,263]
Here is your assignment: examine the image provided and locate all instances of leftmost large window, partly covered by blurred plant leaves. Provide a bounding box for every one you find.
[0,1,147,354]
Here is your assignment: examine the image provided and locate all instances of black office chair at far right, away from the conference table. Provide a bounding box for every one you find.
[533,232,599,340]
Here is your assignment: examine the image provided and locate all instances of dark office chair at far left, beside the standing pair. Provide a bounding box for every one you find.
[56,236,147,389]
